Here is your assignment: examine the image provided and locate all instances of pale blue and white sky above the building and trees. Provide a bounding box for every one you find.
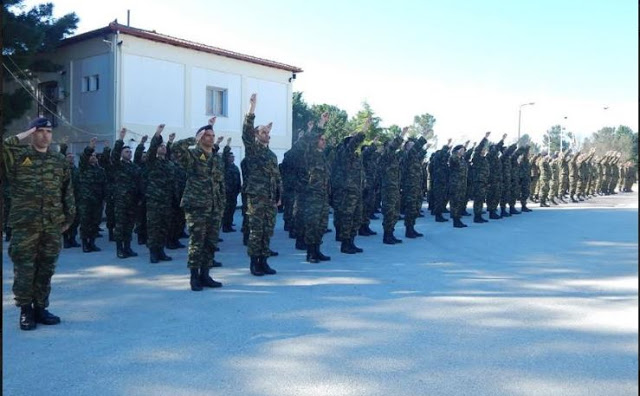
[21,0,638,145]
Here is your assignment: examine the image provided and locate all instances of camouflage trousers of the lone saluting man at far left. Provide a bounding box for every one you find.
[9,219,61,308]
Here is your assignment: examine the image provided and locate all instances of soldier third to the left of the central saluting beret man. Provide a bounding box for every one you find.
[74,138,107,253]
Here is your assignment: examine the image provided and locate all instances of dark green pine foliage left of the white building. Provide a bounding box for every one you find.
[2,0,78,129]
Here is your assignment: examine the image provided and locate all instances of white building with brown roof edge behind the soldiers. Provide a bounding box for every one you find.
[9,22,302,163]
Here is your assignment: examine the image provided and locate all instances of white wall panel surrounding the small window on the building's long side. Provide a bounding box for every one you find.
[190,67,242,133]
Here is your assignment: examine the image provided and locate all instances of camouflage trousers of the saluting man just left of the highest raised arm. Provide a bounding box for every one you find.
[185,208,219,269]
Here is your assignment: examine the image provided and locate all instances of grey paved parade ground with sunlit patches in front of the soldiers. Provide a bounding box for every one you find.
[2,193,638,396]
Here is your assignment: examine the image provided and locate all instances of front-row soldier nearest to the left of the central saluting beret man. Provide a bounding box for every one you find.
[145,124,178,263]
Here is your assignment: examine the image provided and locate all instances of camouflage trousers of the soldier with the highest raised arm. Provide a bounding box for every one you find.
[247,195,277,257]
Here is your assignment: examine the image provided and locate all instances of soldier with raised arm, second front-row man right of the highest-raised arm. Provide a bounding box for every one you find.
[331,127,369,254]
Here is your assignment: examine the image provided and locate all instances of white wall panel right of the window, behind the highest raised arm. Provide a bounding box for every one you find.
[242,78,290,138]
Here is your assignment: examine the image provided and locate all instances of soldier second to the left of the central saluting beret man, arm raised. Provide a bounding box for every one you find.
[111,128,142,258]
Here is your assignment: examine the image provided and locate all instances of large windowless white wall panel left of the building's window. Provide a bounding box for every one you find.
[122,54,185,128]
